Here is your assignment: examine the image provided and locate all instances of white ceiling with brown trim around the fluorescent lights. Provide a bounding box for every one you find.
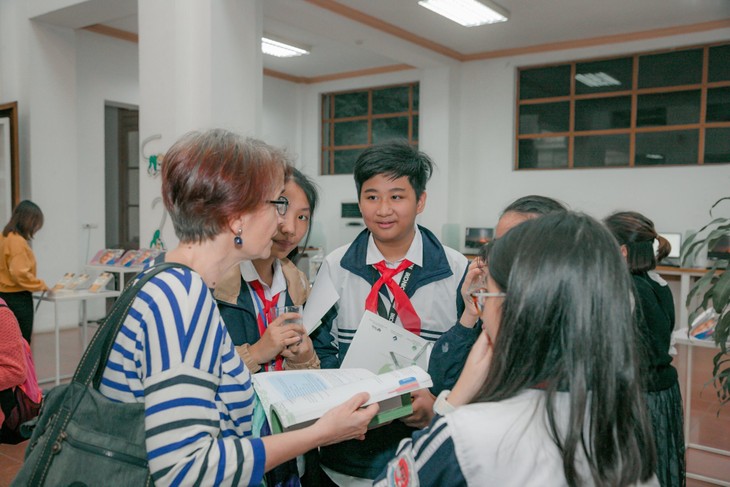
[39,0,730,78]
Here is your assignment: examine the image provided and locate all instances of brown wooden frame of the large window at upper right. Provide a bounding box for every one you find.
[514,41,730,171]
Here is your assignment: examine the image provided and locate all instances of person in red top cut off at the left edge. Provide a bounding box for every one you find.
[0,298,26,443]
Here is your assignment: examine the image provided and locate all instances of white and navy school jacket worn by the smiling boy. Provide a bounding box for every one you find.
[312,226,468,479]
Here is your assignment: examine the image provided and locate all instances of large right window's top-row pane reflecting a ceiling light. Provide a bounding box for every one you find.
[575,57,634,95]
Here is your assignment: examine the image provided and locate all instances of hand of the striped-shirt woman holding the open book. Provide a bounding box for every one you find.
[312,392,380,446]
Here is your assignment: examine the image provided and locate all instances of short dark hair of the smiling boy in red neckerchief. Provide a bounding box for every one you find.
[353,140,434,199]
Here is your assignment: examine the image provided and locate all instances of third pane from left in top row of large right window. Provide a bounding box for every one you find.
[639,49,702,88]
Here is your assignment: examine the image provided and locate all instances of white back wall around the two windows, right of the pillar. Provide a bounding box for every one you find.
[286,29,730,258]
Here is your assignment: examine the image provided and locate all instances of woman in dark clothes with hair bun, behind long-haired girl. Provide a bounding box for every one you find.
[604,211,686,487]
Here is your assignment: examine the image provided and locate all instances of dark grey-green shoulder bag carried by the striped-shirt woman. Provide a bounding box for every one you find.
[11,263,184,487]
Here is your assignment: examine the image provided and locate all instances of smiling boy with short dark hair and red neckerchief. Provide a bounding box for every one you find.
[312,141,468,485]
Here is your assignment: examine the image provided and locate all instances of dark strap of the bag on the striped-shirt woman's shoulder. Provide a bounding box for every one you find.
[29,262,189,485]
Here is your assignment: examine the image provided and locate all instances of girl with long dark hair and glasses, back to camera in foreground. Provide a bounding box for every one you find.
[374,212,656,487]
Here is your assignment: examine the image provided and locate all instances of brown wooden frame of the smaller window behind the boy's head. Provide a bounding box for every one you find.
[319,81,420,176]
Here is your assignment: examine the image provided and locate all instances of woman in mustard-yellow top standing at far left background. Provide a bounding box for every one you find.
[0,200,48,343]
